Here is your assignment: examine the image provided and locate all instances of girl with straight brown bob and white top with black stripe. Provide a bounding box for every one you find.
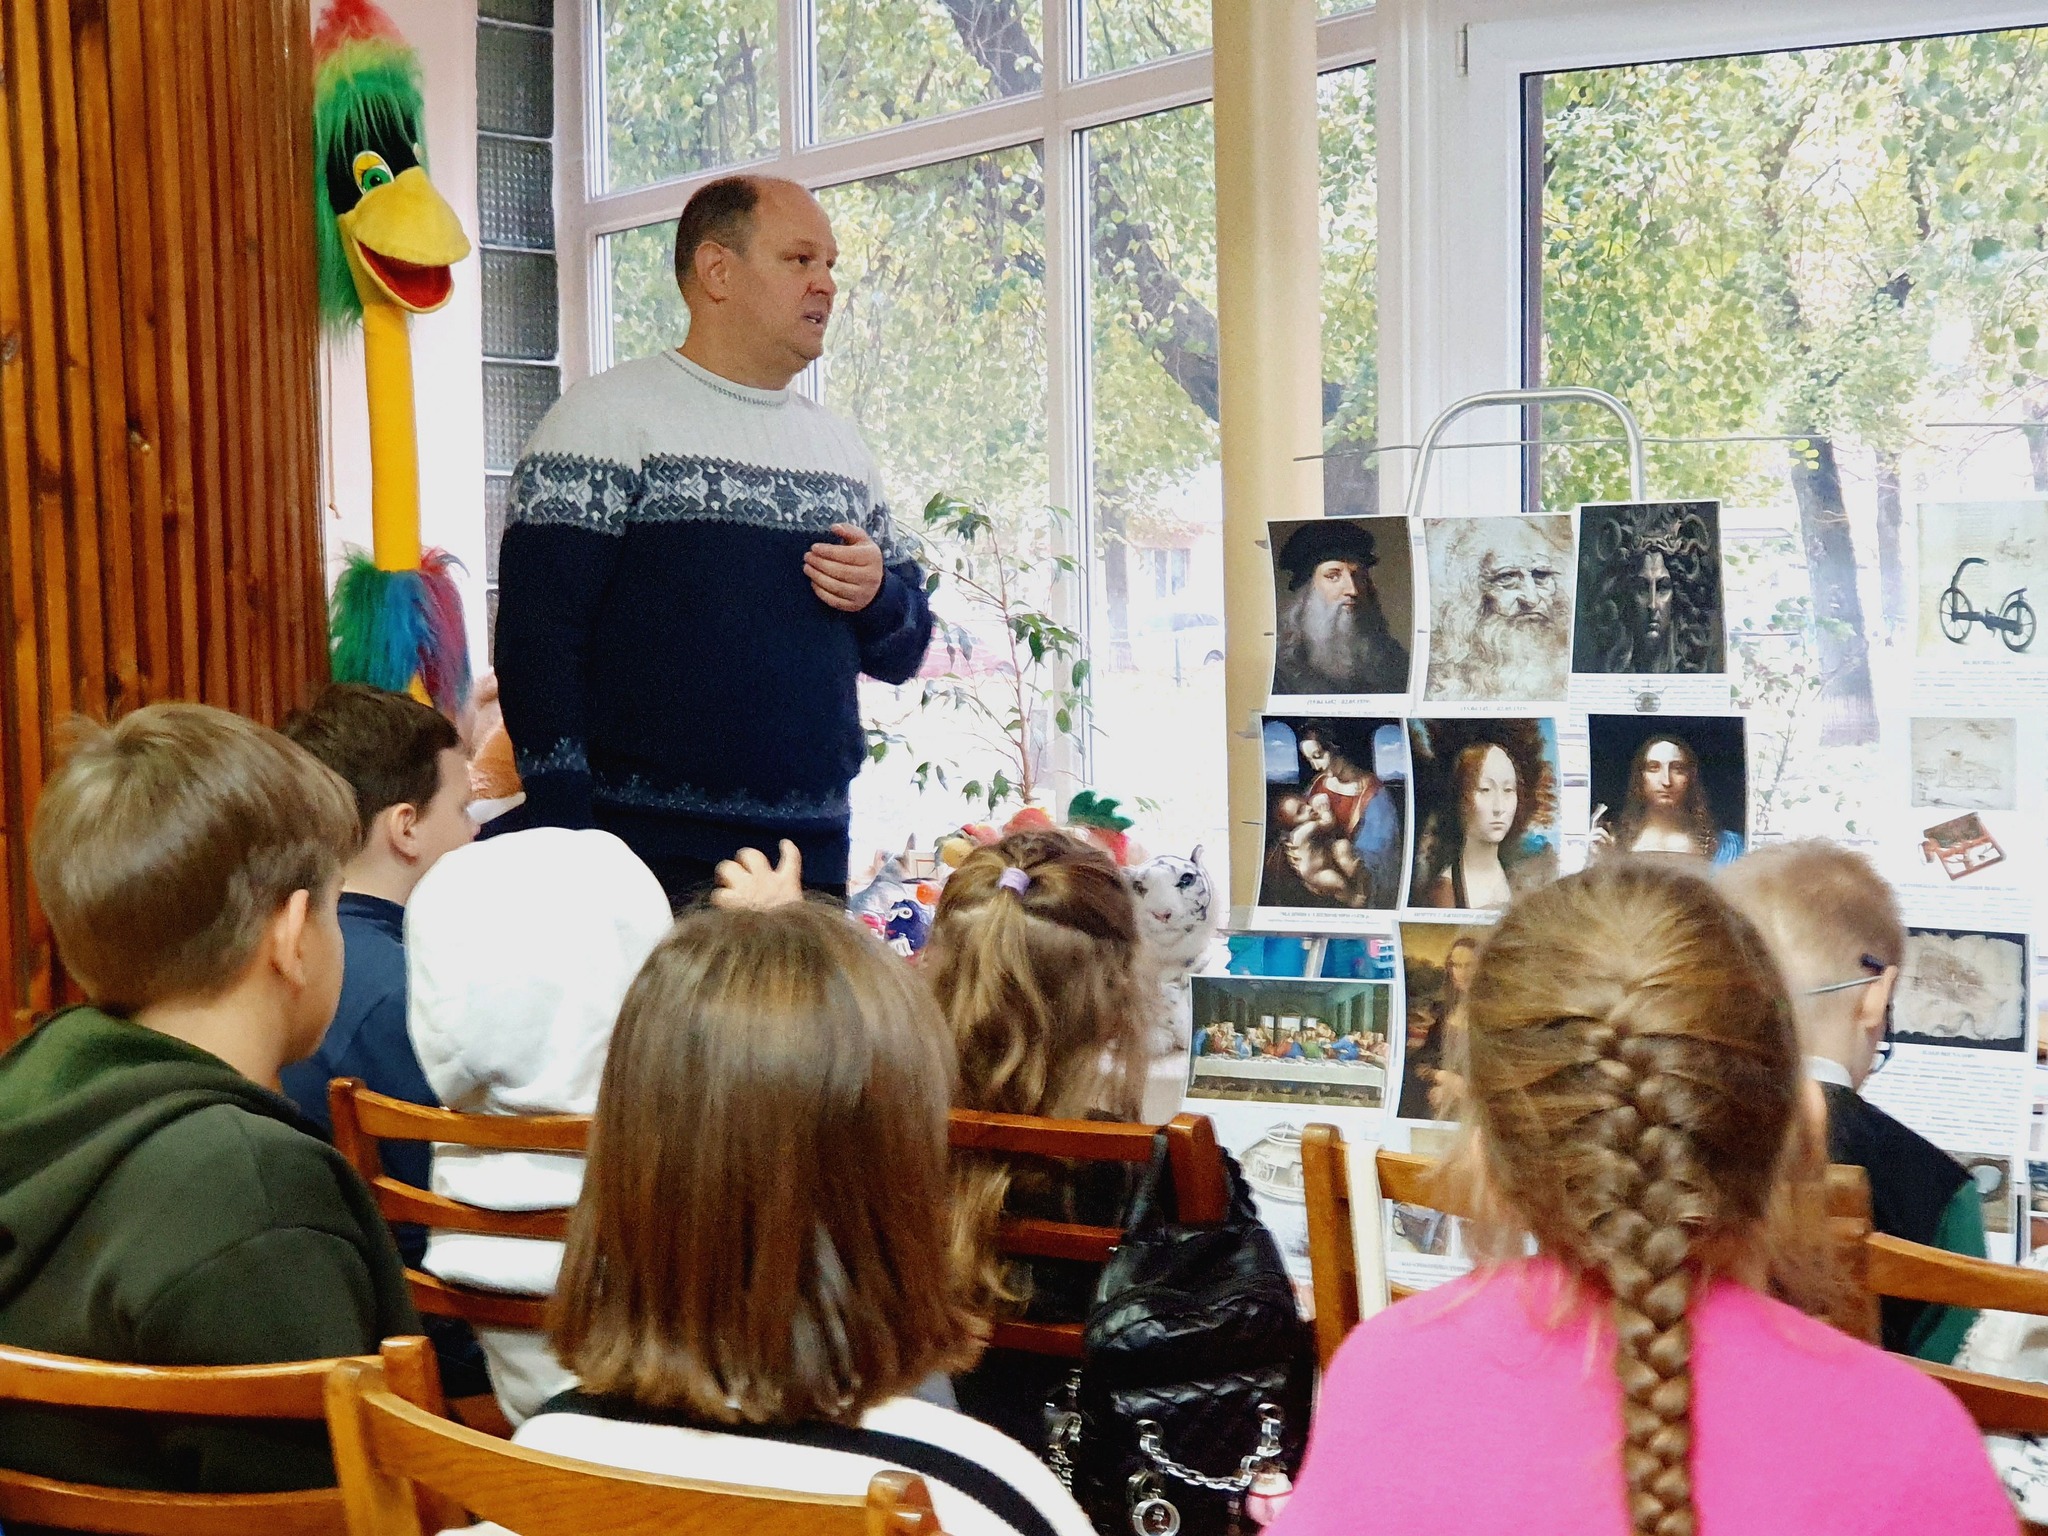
[464,901,1092,1536]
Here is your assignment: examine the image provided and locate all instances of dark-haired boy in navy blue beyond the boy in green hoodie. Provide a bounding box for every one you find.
[283,682,475,1264]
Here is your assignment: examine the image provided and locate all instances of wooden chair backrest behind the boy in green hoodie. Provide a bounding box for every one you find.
[0,1337,442,1536]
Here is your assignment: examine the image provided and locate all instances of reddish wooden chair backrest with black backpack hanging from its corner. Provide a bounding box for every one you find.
[946,1110,1231,1360]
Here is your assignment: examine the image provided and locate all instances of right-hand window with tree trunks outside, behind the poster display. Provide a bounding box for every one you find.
[1526,29,2048,838]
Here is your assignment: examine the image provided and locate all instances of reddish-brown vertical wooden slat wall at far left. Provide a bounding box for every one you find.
[0,0,328,1042]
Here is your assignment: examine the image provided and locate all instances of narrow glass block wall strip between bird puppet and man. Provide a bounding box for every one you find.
[477,0,561,643]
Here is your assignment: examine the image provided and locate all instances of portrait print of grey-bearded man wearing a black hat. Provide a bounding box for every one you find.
[1272,518,1413,694]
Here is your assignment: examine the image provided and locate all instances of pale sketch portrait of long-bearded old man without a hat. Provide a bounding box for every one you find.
[1423,516,1573,702]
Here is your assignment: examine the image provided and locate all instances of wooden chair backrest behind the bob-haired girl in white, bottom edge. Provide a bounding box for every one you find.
[329,1360,938,1536]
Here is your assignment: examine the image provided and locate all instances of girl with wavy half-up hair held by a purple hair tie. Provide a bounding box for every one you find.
[922,831,1157,1440]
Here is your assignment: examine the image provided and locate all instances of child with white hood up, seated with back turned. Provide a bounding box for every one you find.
[406,827,672,1423]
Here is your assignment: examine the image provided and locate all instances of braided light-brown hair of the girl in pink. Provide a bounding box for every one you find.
[1466,858,1819,1536]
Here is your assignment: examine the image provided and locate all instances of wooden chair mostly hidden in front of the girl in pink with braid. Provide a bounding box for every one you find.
[1300,1124,1875,1366]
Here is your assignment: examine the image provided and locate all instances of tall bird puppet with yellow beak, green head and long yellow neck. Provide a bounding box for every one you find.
[313,0,469,717]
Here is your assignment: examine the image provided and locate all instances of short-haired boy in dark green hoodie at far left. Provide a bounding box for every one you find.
[0,705,420,1491]
